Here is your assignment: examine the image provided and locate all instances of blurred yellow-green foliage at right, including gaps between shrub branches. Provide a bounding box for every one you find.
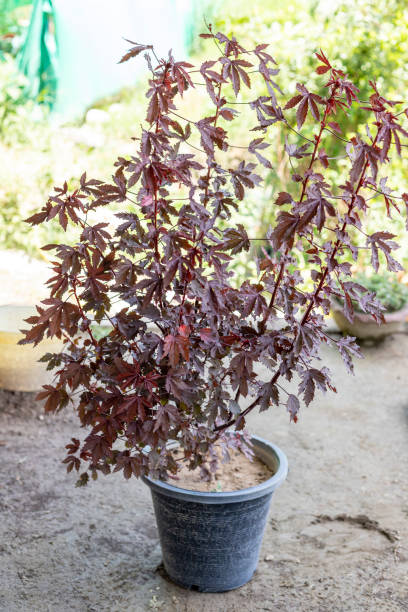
[203,0,408,280]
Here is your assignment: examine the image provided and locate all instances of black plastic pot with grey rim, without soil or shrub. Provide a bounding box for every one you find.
[143,436,288,592]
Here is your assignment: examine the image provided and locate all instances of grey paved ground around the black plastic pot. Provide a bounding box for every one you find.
[0,335,408,612]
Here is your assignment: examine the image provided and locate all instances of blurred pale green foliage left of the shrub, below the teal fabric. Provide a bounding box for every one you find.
[0,74,147,257]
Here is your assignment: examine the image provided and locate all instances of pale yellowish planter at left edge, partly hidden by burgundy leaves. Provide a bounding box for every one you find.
[0,304,62,391]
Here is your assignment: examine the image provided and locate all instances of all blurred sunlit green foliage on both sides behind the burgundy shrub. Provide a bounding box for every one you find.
[0,0,408,283]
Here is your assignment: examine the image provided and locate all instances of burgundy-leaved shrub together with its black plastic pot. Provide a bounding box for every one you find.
[24,27,408,591]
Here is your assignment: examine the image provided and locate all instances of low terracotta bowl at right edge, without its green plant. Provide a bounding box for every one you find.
[332,303,408,339]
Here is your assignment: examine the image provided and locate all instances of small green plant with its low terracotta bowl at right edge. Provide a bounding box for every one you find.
[332,272,408,339]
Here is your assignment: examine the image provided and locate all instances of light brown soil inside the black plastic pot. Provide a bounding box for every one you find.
[170,450,273,493]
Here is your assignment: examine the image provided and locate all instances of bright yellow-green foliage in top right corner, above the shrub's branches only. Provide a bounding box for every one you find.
[210,0,408,101]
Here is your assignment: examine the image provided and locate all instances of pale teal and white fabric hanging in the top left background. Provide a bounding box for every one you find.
[19,0,196,121]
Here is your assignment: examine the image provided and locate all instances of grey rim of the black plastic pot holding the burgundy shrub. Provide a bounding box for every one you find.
[142,435,288,504]
